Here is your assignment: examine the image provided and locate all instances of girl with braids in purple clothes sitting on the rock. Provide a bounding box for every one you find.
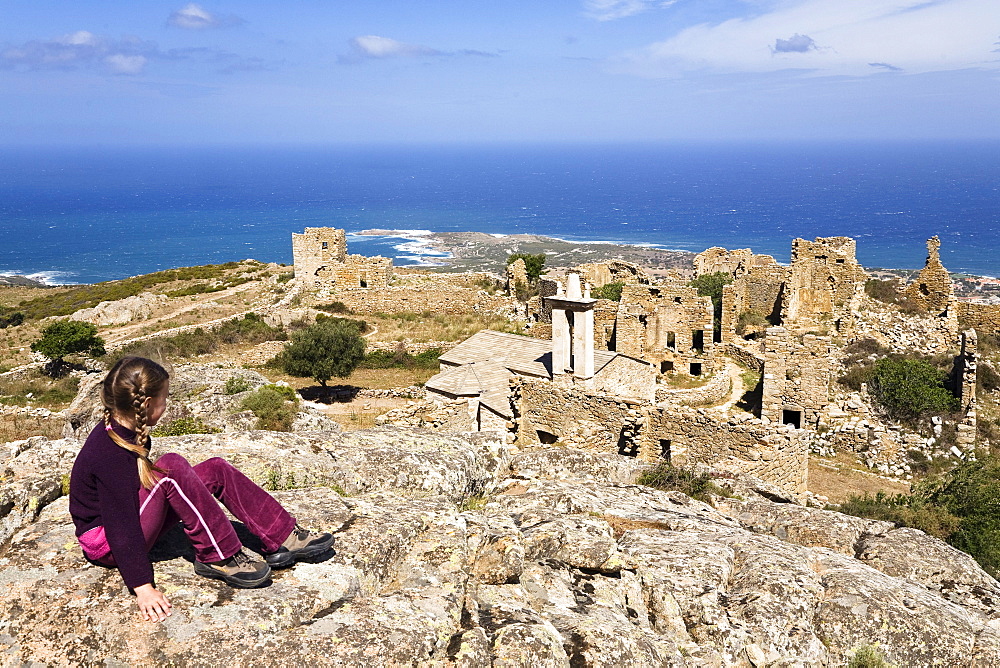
[69,357,333,621]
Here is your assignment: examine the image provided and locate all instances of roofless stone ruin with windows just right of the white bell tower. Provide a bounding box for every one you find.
[615,283,715,375]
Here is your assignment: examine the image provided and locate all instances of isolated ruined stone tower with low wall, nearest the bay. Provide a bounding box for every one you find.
[292,227,392,289]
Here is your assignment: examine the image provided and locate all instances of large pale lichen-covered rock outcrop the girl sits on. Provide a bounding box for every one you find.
[0,429,1000,667]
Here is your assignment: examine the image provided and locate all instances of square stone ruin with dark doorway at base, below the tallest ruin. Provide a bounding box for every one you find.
[760,327,833,427]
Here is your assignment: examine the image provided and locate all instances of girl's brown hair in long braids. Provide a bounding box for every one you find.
[101,357,170,489]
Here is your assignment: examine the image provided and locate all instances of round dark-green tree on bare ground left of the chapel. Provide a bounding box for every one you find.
[279,318,365,387]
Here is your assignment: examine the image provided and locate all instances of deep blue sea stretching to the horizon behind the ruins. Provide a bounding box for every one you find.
[0,142,1000,283]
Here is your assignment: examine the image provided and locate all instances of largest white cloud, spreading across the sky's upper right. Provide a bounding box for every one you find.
[618,0,1000,76]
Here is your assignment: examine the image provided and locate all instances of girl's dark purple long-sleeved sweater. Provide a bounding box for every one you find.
[69,422,153,589]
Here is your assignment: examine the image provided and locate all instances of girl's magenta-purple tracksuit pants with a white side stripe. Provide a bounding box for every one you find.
[102,453,295,566]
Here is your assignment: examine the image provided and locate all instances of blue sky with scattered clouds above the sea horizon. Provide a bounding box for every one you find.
[0,0,1000,145]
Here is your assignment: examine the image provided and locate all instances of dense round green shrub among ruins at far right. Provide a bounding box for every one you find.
[868,357,958,422]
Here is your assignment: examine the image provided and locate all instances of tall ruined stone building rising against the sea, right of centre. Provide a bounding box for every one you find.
[781,237,868,336]
